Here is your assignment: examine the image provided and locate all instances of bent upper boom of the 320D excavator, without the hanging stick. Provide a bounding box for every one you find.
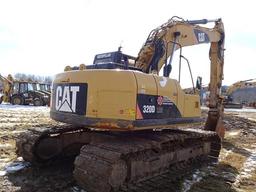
[135,16,224,73]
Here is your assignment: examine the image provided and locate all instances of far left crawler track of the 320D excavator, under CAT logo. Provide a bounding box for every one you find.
[16,125,90,165]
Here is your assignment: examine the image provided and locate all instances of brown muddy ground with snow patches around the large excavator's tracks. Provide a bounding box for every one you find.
[0,105,256,192]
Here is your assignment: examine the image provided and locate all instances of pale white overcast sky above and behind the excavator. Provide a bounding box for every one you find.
[0,0,256,87]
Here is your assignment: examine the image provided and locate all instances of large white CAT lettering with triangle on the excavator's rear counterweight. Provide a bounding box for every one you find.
[55,86,80,113]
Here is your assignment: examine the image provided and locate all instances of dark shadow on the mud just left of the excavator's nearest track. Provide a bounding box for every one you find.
[8,162,75,192]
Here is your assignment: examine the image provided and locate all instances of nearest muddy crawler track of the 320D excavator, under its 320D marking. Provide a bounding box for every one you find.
[74,130,221,192]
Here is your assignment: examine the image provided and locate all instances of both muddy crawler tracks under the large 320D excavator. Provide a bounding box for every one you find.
[17,125,221,192]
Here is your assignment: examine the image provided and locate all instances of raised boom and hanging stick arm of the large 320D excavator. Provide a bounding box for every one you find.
[135,18,225,136]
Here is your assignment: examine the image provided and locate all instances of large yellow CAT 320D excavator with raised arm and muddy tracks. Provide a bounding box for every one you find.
[17,17,224,192]
